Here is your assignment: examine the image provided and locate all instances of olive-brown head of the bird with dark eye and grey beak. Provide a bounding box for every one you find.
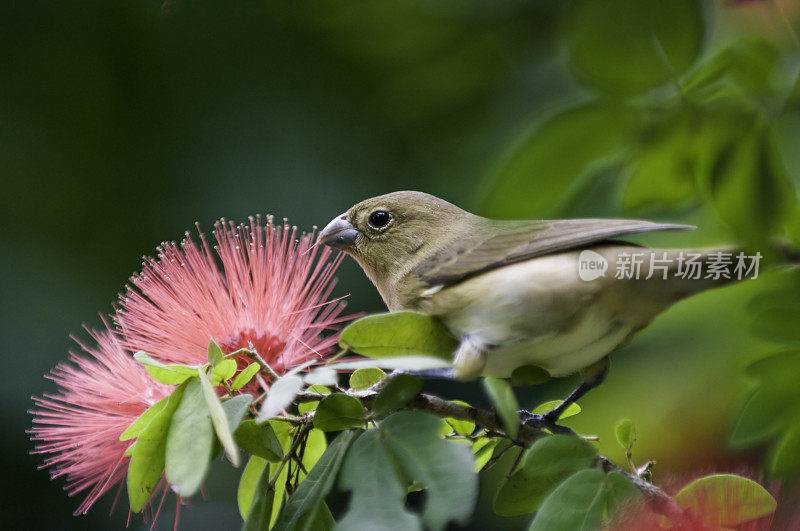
[318,192,475,292]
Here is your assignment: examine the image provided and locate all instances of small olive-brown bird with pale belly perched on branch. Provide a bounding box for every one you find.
[317,191,758,427]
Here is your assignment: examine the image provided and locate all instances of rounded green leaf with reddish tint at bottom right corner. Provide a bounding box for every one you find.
[675,474,777,528]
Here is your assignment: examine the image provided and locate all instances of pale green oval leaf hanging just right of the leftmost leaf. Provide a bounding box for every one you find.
[165,378,214,498]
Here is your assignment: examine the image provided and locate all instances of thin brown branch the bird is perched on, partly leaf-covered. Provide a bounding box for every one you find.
[295,384,684,520]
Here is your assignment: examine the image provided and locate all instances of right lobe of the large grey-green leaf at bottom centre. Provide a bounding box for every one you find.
[379,411,478,530]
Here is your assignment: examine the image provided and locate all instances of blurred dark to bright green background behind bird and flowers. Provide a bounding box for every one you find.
[6,0,800,529]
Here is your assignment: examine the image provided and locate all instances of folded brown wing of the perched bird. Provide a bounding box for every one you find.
[412,219,695,286]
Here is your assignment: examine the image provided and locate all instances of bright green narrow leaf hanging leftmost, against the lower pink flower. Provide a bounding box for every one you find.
[127,384,186,513]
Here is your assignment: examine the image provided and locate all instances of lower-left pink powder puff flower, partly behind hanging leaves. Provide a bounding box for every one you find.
[30,329,172,515]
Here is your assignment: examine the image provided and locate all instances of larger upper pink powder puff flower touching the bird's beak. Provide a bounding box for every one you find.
[115,216,350,389]
